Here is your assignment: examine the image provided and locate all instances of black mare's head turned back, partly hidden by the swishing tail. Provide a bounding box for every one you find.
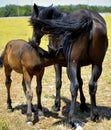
[30,4,62,44]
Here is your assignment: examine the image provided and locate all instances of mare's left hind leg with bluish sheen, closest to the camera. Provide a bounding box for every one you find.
[67,62,79,126]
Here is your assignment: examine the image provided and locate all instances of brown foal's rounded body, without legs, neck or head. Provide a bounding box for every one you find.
[4,40,40,73]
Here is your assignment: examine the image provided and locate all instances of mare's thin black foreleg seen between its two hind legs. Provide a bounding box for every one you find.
[77,68,89,112]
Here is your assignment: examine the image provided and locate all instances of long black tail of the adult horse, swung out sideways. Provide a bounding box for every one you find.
[31,15,93,38]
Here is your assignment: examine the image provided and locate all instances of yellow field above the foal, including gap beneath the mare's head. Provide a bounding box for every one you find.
[0,17,48,49]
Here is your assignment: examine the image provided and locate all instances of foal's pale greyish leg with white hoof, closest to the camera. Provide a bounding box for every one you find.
[23,68,33,125]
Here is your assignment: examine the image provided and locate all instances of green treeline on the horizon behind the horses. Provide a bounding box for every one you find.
[0,5,111,17]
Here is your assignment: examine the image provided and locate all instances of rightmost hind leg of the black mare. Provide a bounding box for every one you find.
[89,65,102,121]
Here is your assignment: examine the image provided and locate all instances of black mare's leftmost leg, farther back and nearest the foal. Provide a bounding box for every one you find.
[52,64,62,111]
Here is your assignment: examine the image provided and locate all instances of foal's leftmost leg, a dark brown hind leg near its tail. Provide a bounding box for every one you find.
[5,66,12,112]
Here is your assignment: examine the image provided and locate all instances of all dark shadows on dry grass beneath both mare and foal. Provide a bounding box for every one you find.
[14,97,111,126]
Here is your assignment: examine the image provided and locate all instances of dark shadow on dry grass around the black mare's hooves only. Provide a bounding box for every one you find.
[53,97,111,126]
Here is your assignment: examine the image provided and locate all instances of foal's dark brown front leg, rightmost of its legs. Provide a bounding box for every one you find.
[36,68,44,117]
